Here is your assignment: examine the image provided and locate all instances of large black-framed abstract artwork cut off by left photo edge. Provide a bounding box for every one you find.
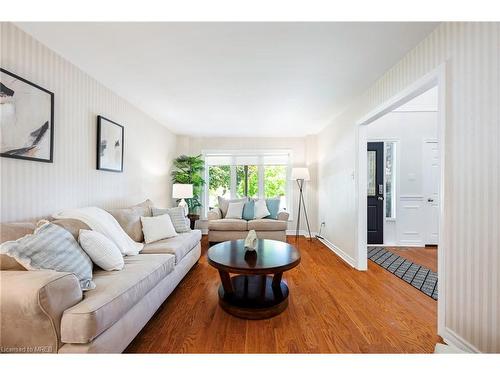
[0,68,54,163]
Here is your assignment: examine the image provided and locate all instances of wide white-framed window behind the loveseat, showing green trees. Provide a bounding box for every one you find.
[204,151,291,212]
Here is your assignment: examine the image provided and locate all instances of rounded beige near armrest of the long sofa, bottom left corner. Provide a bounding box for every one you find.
[0,270,82,353]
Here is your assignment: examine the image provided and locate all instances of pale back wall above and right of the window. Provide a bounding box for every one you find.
[177,136,319,232]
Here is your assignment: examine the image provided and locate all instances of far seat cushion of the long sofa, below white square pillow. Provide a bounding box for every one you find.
[141,229,201,264]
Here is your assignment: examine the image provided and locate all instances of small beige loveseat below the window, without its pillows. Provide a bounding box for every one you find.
[208,207,289,244]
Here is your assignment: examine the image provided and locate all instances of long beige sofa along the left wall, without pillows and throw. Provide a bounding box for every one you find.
[0,203,201,353]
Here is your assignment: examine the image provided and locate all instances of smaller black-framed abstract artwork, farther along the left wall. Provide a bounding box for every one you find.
[97,116,123,172]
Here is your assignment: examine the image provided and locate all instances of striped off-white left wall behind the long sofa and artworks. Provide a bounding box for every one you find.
[0,23,176,222]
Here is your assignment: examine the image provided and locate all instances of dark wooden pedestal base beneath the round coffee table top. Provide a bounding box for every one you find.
[219,275,288,319]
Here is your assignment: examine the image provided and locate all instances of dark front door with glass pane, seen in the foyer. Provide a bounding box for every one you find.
[367,142,384,244]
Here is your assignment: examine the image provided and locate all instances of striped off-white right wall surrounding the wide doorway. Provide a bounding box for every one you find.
[318,23,500,352]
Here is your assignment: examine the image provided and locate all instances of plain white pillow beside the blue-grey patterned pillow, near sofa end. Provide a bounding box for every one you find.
[78,229,124,271]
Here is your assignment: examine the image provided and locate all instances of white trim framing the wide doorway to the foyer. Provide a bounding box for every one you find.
[355,63,448,336]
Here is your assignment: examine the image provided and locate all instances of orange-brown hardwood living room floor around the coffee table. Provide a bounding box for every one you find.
[126,236,439,353]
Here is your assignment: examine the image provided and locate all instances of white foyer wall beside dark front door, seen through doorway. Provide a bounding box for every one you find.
[366,104,438,246]
